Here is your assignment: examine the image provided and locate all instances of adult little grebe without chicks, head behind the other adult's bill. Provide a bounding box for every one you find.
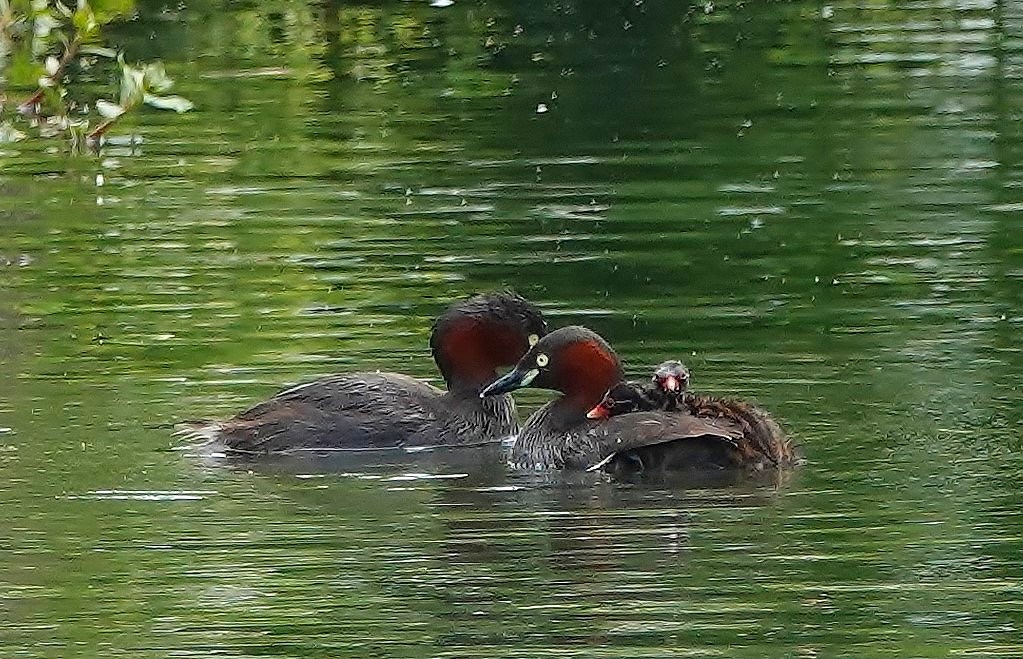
[181,293,547,453]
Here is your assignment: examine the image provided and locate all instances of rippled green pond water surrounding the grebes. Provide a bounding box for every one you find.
[0,0,1023,657]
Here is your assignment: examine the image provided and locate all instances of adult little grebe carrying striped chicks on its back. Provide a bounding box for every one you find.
[481,326,757,473]
